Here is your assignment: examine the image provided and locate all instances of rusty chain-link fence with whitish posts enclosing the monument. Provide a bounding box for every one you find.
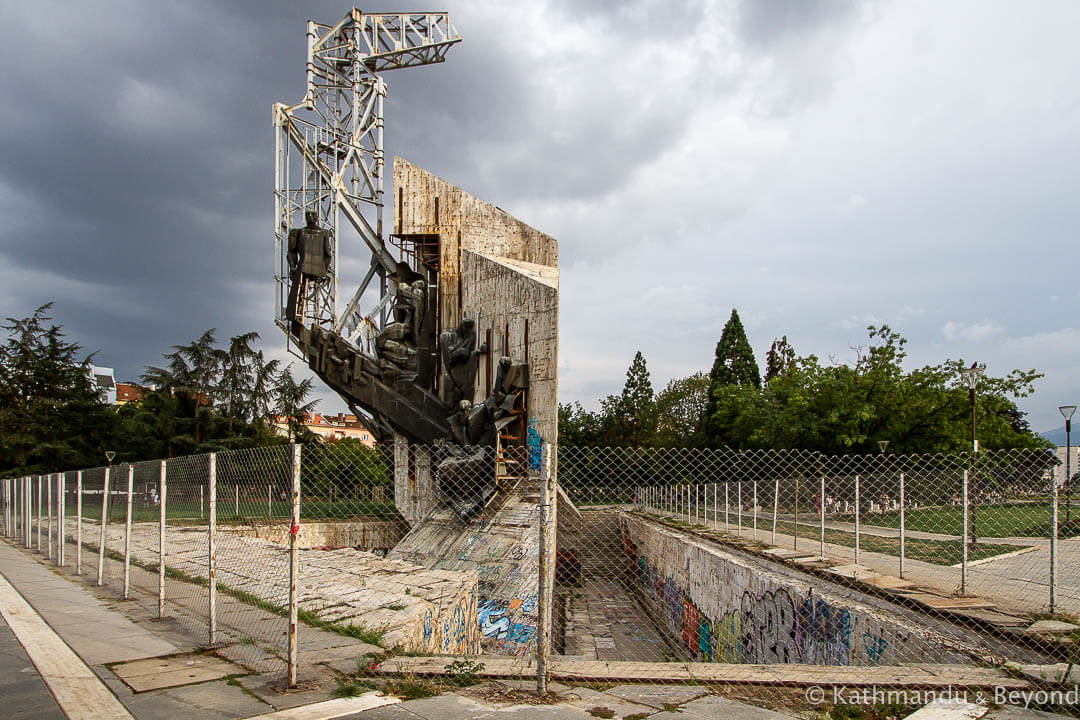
[2,441,1080,712]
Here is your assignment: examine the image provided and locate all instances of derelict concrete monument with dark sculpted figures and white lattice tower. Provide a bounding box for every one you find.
[274,10,577,654]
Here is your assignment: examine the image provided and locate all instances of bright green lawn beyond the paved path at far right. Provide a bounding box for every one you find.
[829,503,1080,538]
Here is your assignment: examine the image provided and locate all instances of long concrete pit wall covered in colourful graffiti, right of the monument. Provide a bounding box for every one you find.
[620,513,972,665]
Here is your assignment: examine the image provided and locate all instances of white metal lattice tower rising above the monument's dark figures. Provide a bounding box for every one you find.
[273,8,461,354]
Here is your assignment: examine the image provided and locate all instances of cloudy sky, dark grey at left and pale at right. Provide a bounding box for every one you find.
[0,0,1080,431]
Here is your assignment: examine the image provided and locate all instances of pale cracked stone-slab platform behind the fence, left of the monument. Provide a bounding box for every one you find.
[78,522,481,653]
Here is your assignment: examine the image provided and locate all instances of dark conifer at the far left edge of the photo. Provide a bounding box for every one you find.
[0,303,117,475]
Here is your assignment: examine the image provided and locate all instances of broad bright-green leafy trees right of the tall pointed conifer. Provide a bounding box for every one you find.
[708,325,1047,453]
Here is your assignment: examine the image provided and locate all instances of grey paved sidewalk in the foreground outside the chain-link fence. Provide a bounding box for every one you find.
[0,542,807,720]
